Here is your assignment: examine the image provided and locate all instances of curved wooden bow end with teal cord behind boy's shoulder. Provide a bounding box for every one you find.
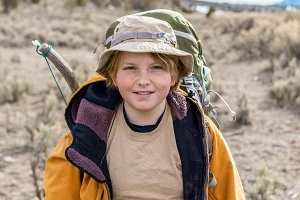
[32,40,79,102]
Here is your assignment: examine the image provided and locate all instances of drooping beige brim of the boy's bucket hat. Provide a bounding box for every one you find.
[96,41,193,76]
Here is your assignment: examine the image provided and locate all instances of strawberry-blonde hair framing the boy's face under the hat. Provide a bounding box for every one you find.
[102,51,184,92]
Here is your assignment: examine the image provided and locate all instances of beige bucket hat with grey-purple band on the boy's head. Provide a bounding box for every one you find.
[96,15,193,76]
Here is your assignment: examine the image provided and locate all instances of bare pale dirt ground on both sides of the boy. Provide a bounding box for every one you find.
[0,1,300,200]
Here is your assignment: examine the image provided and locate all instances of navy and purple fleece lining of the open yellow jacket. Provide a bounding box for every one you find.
[65,76,209,200]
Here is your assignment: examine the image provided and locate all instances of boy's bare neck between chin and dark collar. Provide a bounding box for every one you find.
[124,100,166,126]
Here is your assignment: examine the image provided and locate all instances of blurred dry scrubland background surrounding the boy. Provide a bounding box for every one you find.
[0,0,300,200]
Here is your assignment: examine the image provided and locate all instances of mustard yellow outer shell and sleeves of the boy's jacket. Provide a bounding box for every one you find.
[44,74,245,200]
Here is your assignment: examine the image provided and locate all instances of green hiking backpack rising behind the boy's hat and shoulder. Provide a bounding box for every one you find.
[104,9,219,188]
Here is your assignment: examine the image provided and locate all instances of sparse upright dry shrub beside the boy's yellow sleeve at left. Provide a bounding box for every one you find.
[25,90,65,200]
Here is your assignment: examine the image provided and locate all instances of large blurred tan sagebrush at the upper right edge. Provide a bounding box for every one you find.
[231,12,300,60]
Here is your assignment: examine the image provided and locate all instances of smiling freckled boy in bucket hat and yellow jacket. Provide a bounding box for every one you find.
[44,16,244,200]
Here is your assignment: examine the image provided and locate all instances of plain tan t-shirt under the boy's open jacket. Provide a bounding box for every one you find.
[107,104,183,200]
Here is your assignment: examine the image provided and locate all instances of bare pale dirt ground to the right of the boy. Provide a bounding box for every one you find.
[213,61,300,199]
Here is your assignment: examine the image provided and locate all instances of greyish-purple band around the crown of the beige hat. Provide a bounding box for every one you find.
[111,32,176,47]
